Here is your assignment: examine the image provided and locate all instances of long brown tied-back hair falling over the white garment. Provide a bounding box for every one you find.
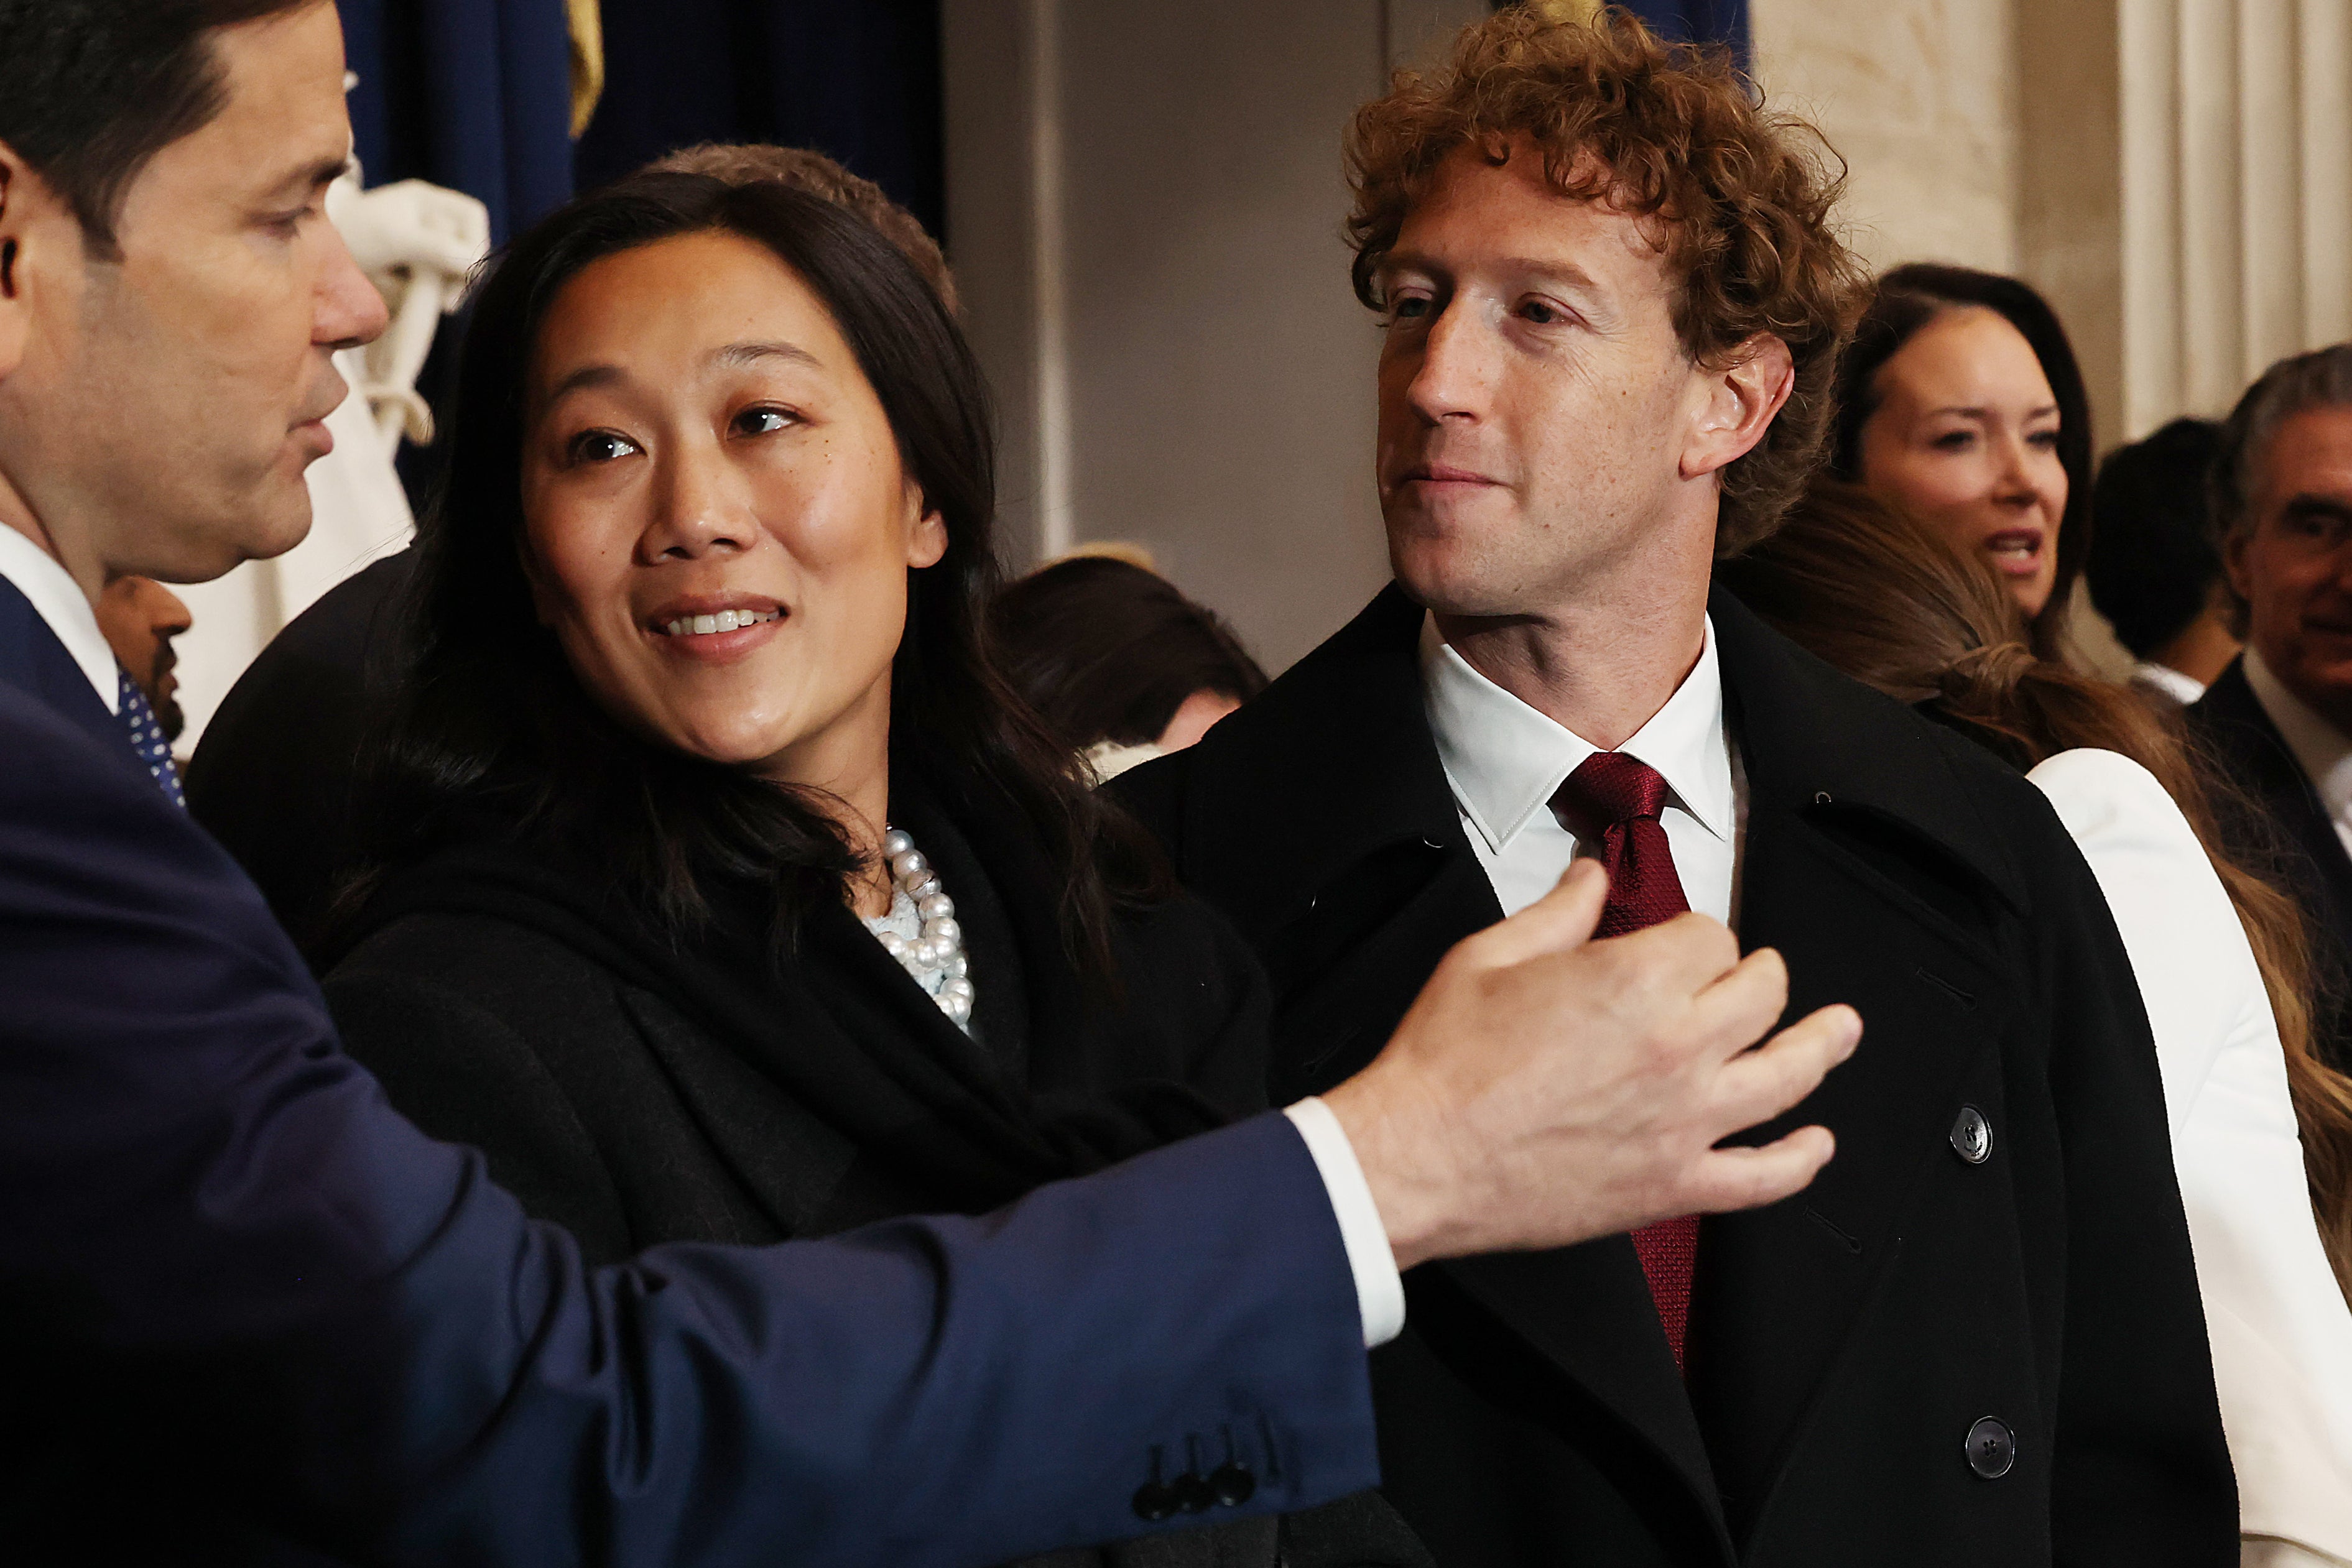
[1717,479,2352,1300]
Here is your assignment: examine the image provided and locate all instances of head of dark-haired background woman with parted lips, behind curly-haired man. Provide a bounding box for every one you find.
[1830,263,2093,658]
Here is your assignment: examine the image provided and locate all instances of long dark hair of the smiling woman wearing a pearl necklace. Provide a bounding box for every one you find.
[346,174,1164,978]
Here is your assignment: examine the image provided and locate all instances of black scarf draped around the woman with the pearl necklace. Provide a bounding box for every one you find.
[339,776,1254,1213]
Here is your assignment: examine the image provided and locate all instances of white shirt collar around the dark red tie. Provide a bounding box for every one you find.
[1420,616,1748,924]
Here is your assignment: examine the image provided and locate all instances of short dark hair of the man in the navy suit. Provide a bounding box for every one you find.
[0,0,318,254]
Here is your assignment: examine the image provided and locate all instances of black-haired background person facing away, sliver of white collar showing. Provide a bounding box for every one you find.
[2084,418,2239,710]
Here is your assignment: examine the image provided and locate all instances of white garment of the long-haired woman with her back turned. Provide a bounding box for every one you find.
[2030,750,2352,1568]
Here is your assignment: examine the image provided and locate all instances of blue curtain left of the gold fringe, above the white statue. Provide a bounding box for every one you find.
[336,0,572,242]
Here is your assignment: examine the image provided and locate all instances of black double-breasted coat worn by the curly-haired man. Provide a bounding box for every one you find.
[1119,588,2237,1568]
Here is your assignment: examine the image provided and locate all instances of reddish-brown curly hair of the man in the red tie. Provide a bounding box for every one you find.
[1348,7,1865,557]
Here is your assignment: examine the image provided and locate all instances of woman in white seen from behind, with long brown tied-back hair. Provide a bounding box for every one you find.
[1721,482,2352,1568]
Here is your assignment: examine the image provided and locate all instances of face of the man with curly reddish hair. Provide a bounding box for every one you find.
[1378,141,1712,616]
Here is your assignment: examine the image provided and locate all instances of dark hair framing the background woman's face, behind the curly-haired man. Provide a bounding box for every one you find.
[1830,261,2096,658]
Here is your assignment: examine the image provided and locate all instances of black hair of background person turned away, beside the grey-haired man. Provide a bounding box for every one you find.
[2081,418,2220,658]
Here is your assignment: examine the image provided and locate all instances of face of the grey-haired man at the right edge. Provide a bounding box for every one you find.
[2223,409,2352,731]
